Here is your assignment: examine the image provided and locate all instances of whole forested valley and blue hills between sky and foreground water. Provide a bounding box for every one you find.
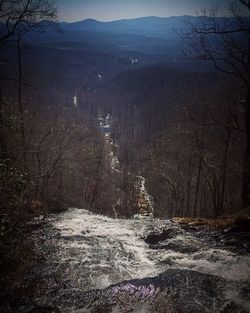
[1,6,248,217]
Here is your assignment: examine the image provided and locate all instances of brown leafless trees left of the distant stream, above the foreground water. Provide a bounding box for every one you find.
[0,81,125,220]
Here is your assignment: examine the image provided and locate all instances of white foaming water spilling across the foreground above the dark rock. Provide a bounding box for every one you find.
[46,209,250,290]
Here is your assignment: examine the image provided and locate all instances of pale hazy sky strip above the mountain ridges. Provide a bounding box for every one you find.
[57,0,228,21]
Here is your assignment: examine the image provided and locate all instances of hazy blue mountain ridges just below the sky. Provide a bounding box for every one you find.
[0,16,213,84]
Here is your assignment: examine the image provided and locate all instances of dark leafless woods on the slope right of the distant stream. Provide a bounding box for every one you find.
[94,67,245,217]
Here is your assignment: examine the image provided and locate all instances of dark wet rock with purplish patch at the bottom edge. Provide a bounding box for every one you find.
[58,269,246,313]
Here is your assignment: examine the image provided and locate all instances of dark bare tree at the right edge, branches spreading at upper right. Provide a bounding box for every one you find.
[185,0,250,210]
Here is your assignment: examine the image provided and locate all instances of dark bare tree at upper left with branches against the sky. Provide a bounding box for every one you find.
[0,0,56,164]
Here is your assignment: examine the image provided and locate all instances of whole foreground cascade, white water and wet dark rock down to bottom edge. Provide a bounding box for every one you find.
[22,209,250,313]
